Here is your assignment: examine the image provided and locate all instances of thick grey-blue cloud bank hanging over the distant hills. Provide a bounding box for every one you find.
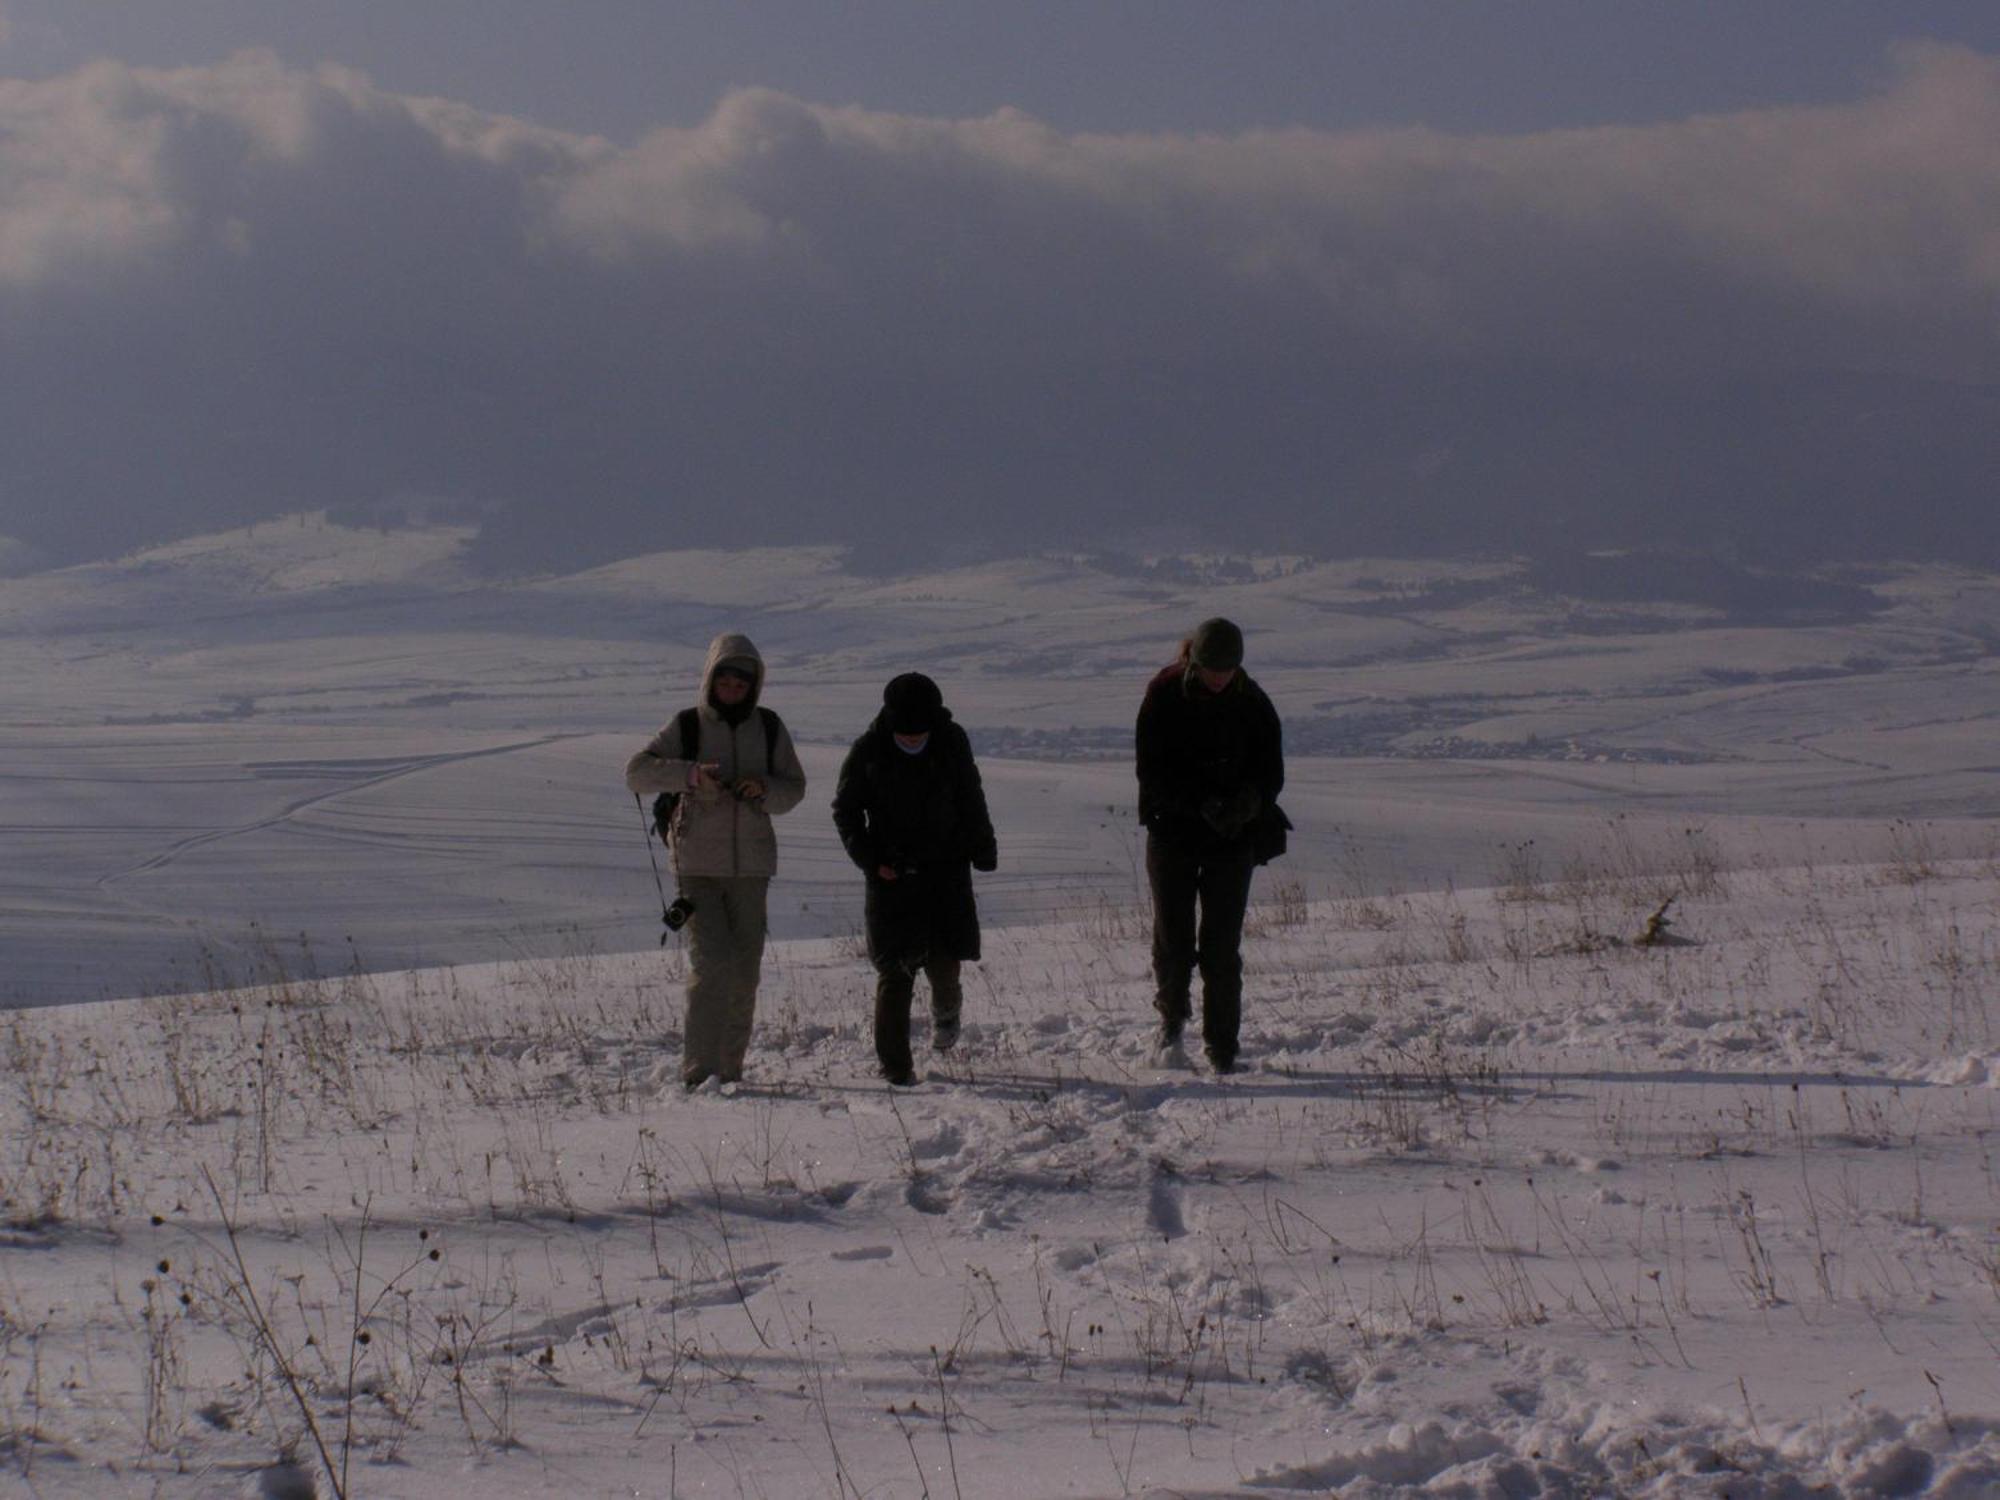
[0,46,2000,566]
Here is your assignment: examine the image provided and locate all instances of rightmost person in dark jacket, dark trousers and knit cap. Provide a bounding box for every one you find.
[1136,620,1284,1072]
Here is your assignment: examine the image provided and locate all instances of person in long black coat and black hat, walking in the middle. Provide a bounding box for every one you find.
[834,672,1000,1086]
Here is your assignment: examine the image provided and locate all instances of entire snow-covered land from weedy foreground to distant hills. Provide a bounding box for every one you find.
[0,518,2000,1500]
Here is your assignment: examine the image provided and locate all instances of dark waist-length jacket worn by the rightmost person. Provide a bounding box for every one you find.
[1134,666,1284,856]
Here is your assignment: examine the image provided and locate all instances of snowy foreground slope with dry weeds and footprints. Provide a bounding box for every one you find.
[0,844,2000,1500]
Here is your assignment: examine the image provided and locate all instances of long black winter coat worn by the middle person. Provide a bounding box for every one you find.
[834,710,998,966]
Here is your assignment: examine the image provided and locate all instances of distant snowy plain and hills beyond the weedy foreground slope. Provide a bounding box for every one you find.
[0,514,2000,1002]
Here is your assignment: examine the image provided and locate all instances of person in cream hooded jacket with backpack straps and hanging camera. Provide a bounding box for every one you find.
[626,632,806,1088]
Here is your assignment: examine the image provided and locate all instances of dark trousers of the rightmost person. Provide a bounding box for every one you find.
[1146,836,1256,1062]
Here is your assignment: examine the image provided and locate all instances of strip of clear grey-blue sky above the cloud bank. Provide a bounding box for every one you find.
[15,0,2000,142]
